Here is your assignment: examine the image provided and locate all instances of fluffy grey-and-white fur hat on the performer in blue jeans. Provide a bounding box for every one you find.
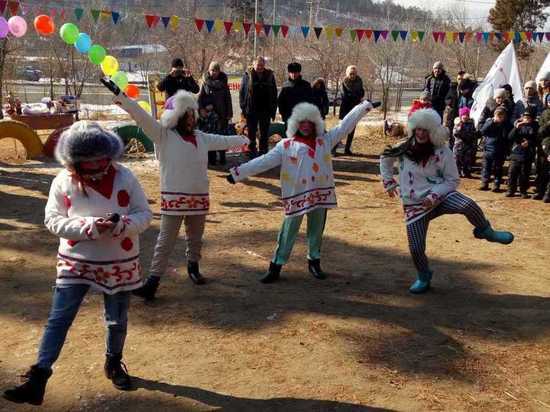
[55,121,124,167]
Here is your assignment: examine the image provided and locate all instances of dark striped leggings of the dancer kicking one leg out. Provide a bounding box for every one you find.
[407,192,488,273]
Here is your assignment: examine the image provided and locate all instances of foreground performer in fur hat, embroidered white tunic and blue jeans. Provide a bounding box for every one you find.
[4,122,153,405]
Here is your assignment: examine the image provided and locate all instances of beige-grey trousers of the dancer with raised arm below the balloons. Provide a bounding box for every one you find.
[149,215,206,276]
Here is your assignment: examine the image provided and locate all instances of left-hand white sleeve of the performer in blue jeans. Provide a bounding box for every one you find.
[44,176,101,240]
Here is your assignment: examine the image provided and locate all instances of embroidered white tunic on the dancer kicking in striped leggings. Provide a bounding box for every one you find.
[380,146,460,224]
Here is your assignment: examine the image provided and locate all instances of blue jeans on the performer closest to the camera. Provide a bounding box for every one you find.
[37,285,130,369]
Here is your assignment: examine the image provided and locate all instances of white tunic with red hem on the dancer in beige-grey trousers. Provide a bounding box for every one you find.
[114,94,249,215]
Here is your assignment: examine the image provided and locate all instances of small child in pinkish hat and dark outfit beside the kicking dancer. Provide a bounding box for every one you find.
[453,107,478,179]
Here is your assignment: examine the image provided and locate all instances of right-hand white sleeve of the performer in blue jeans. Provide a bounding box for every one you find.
[112,173,153,237]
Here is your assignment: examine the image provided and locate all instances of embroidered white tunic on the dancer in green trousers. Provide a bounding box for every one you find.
[231,102,371,216]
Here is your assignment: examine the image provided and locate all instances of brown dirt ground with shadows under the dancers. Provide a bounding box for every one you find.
[0,123,550,411]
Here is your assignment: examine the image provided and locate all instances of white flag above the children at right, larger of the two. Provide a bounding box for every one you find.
[471,42,523,125]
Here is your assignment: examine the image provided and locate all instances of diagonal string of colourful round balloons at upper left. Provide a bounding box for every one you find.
[32,14,147,107]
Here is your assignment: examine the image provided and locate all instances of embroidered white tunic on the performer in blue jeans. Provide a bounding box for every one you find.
[44,164,153,294]
